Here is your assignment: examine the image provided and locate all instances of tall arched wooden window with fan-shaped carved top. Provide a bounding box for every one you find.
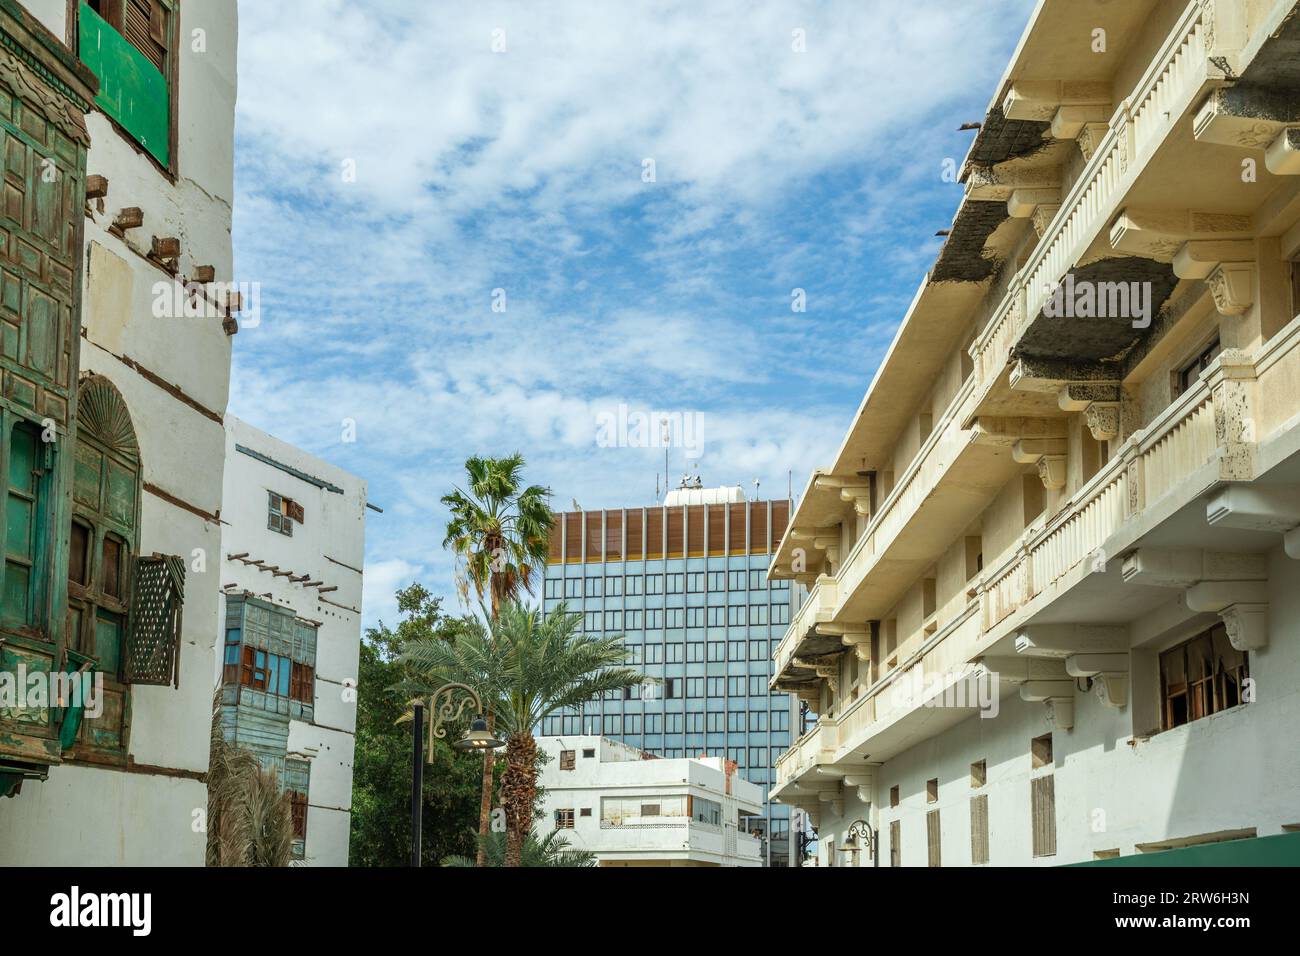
[68,376,142,750]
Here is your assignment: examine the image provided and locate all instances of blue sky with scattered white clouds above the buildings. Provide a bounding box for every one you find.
[230,0,1034,626]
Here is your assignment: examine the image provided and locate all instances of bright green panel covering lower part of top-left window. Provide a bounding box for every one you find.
[79,3,172,166]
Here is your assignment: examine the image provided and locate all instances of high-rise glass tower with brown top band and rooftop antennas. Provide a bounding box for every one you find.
[542,486,797,866]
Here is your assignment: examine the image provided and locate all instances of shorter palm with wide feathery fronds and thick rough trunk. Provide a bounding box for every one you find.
[403,601,641,866]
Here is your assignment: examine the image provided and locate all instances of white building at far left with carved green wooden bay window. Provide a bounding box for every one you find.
[0,0,238,865]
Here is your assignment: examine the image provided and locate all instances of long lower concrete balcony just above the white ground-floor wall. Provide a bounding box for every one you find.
[772,317,1300,785]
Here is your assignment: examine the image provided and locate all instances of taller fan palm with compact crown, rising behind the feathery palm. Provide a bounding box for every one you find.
[442,451,555,866]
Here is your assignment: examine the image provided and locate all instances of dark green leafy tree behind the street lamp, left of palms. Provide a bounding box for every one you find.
[350,584,482,866]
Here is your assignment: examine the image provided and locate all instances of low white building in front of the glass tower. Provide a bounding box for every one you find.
[537,736,764,866]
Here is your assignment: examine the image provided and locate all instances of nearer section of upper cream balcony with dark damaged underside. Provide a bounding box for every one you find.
[970,0,1300,415]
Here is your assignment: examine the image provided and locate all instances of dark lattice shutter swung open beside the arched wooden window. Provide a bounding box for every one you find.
[125,554,185,687]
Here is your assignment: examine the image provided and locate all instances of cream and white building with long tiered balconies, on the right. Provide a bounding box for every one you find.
[771,0,1300,866]
